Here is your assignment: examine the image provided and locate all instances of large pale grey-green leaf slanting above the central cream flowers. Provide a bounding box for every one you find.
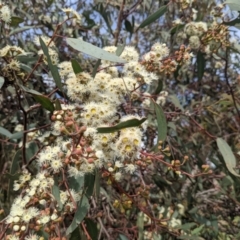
[66,38,126,63]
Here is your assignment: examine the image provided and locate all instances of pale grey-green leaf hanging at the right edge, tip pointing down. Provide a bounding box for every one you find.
[217,138,240,177]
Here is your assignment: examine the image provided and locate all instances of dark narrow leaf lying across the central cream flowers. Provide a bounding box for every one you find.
[97,118,146,133]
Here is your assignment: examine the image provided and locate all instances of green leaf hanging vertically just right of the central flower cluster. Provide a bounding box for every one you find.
[154,102,167,142]
